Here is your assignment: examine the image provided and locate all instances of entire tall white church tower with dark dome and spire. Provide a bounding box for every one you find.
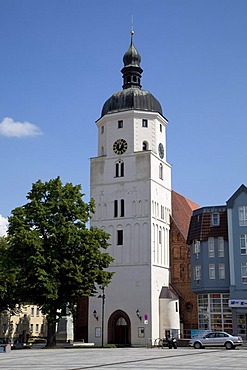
[89,32,179,345]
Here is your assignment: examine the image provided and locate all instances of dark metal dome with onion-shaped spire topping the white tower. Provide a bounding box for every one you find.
[101,31,162,117]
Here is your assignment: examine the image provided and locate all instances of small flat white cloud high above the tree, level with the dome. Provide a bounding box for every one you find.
[0,117,42,137]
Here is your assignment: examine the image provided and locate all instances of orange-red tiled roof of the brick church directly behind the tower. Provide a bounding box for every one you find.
[172,190,199,240]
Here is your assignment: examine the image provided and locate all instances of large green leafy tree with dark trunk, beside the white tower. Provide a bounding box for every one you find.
[8,177,112,347]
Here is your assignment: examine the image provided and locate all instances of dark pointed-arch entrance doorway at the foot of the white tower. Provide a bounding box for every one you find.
[108,310,131,346]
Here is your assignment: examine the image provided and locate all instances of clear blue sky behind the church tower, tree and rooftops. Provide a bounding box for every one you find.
[0,0,247,234]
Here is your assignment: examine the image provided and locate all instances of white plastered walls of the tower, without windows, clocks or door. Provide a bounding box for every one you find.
[89,111,171,344]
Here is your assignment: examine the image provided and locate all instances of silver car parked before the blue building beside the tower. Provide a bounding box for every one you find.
[189,331,243,349]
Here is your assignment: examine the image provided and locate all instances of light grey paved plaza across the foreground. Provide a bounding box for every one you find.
[0,348,247,370]
